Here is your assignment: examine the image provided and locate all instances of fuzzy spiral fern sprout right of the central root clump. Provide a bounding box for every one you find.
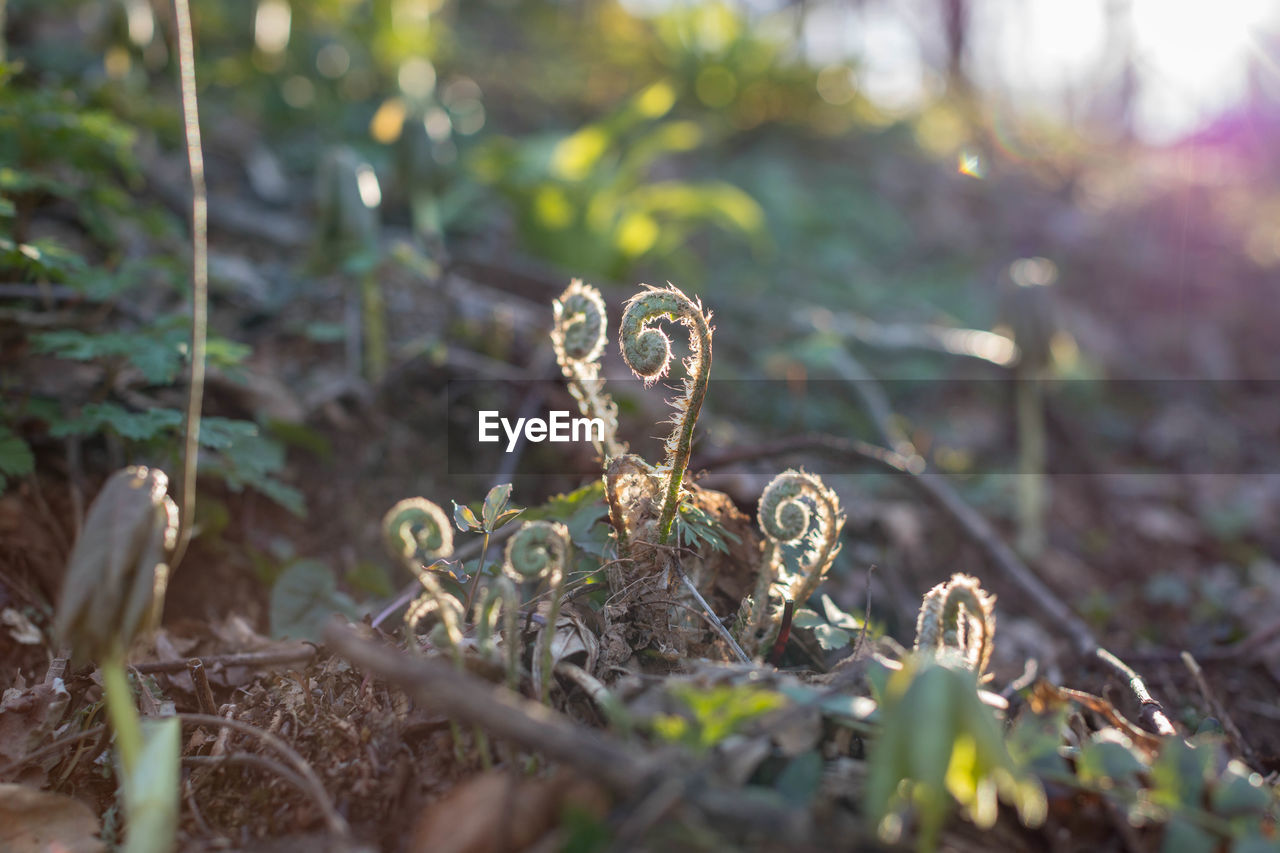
[754,469,845,607]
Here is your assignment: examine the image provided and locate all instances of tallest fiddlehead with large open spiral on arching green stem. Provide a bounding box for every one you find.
[618,283,712,544]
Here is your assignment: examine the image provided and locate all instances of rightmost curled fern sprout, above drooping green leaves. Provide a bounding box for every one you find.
[915,574,996,679]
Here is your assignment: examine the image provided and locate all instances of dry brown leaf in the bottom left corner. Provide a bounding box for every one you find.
[0,784,106,853]
